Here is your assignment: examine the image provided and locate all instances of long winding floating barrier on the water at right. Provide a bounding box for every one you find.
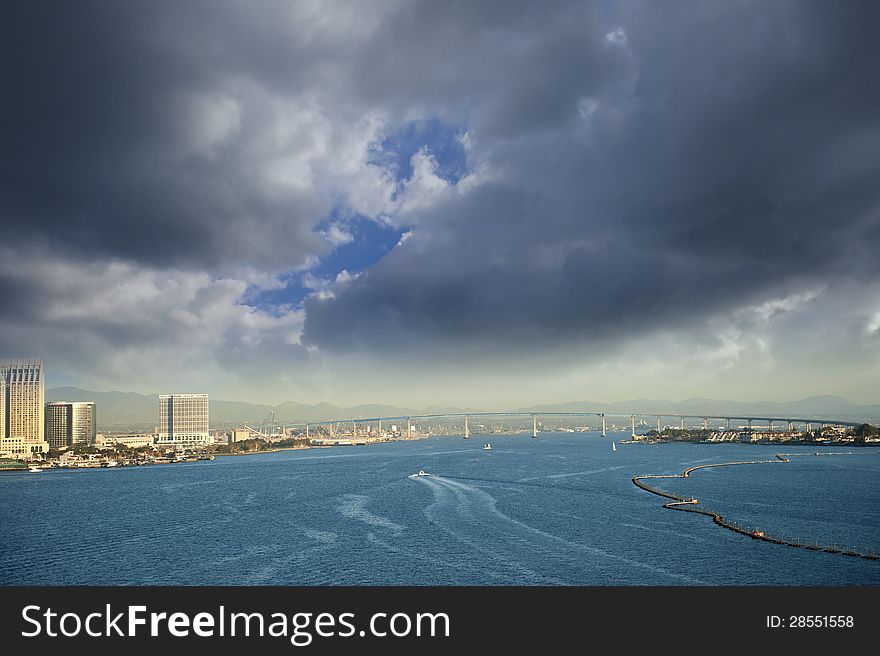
[632,452,880,560]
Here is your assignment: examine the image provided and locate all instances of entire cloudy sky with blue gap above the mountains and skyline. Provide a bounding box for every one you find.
[0,0,880,408]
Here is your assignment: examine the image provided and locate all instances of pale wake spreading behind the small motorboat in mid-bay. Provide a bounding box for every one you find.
[412,476,704,585]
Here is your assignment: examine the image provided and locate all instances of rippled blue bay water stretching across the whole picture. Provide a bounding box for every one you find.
[0,433,880,585]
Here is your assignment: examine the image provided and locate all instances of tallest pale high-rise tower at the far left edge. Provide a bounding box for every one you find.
[0,359,49,458]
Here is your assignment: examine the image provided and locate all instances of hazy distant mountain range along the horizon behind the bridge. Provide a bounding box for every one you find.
[46,387,880,430]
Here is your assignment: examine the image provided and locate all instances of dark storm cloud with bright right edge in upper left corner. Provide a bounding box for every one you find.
[0,1,327,268]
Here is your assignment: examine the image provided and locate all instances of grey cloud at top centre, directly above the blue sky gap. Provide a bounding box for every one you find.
[349,1,627,138]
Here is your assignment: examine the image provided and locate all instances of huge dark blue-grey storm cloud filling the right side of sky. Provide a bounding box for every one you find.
[304,2,880,353]
